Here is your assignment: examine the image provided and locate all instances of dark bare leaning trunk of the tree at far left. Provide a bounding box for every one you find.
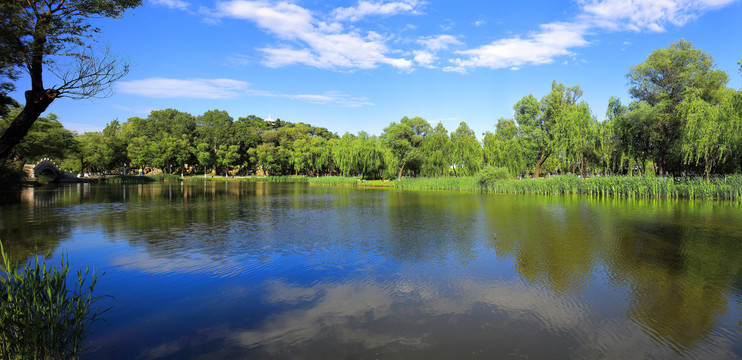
[0,89,59,159]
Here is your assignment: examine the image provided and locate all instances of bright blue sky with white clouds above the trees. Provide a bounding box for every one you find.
[15,0,742,138]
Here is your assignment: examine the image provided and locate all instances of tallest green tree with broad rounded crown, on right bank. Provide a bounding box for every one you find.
[627,39,728,175]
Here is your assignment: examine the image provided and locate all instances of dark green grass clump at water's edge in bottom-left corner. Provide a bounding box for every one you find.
[0,242,106,359]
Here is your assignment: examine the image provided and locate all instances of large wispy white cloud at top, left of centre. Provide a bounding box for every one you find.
[217,0,412,70]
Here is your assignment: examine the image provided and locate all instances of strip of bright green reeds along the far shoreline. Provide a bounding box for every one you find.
[100,172,742,201]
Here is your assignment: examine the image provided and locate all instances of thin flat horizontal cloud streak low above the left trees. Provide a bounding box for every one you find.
[116,78,248,99]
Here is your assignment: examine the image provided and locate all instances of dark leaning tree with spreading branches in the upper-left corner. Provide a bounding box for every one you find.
[0,0,141,159]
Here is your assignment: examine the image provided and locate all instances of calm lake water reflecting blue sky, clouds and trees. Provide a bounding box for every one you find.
[0,183,742,359]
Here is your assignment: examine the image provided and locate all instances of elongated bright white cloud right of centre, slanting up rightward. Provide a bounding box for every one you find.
[451,23,588,71]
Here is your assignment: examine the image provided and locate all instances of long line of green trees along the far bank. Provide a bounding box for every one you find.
[0,40,742,179]
